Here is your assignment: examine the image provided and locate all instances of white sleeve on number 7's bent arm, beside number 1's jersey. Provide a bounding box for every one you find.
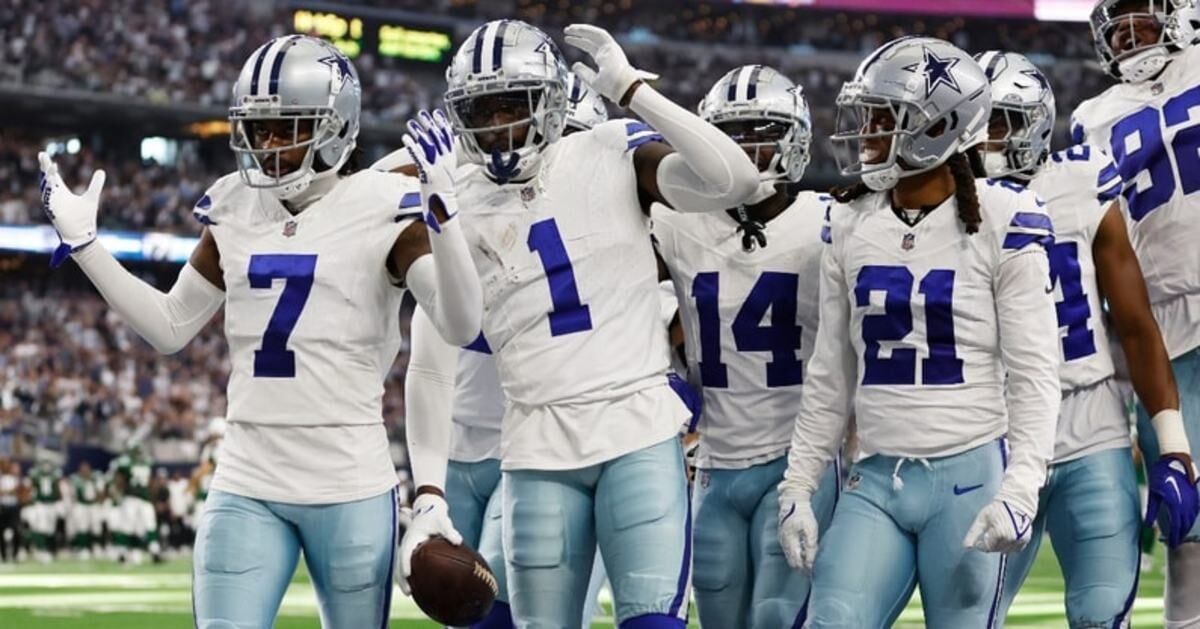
[404,217,484,346]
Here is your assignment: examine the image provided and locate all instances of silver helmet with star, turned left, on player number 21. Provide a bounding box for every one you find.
[830,37,991,191]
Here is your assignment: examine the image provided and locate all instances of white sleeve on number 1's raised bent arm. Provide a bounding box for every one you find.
[629,84,758,211]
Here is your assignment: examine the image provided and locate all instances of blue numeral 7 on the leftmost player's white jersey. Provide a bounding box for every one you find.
[247,253,317,378]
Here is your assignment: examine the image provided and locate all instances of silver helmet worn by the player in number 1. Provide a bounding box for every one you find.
[445,19,568,182]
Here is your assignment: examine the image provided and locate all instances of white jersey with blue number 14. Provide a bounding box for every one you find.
[654,192,830,469]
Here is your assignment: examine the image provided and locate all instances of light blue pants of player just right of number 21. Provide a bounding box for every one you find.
[1003,448,1141,629]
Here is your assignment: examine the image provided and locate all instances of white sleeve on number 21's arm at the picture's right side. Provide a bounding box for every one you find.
[994,246,1062,514]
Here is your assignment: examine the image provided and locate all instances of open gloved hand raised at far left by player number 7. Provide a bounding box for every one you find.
[37,151,104,266]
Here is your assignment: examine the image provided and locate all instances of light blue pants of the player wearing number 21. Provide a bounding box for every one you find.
[806,442,1004,629]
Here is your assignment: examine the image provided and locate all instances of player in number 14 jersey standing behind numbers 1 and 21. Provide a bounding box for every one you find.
[654,65,838,629]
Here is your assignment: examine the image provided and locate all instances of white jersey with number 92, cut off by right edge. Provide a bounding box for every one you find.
[1072,47,1200,358]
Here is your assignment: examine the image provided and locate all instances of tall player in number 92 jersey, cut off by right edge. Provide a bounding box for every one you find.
[1072,0,1200,628]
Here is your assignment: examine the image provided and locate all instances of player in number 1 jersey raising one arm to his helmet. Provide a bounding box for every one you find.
[401,20,758,629]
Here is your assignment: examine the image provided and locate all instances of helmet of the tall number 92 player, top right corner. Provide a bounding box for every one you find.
[1091,0,1200,83]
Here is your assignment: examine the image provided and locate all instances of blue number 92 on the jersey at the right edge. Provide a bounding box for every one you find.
[1110,86,1200,221]
